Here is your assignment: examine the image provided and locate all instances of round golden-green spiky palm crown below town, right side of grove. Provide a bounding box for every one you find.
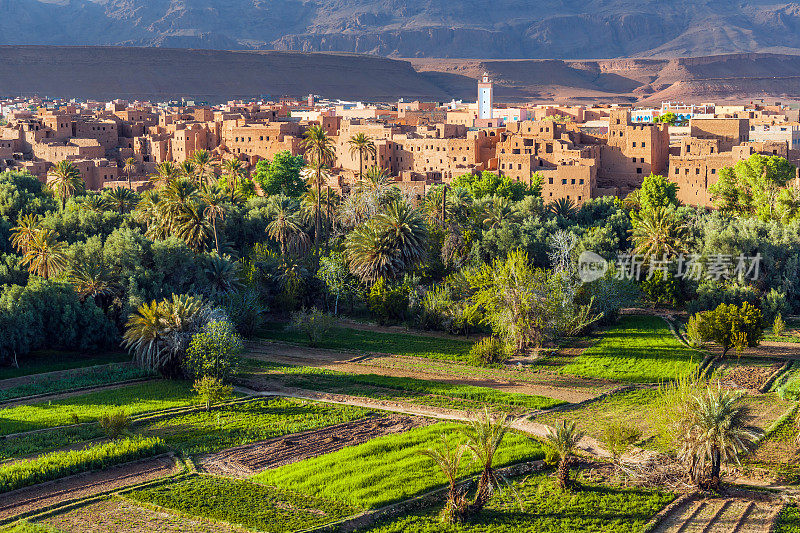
[630,207,688,259]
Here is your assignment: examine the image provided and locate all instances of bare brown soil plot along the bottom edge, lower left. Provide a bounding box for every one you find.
[41,498,246,533]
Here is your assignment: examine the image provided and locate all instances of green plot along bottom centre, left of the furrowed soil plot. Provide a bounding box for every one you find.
[367,474,674,533]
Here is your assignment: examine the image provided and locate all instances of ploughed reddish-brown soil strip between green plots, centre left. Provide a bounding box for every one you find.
[196,414,432,477]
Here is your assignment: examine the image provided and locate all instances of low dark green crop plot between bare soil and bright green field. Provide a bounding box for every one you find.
[126,476,356,533]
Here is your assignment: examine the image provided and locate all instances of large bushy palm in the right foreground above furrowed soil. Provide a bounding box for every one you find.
[680,385,762,491]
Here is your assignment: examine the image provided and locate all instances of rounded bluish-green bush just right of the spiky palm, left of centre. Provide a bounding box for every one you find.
[183,320,242,381]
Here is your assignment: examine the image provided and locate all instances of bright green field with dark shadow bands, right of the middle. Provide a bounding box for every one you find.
[559,315,702,383]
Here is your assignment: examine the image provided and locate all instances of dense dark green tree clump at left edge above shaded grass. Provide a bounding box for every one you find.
[0,277,117,361]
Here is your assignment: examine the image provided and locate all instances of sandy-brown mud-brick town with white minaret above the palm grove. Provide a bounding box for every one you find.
[0,76,800,206]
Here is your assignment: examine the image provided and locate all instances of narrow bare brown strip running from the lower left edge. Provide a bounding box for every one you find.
[0,456,177,519]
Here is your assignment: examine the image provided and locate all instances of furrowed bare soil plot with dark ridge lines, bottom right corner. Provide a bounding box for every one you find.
[653,491,781,533]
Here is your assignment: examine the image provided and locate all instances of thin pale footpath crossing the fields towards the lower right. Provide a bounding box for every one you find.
[235,387,611,458]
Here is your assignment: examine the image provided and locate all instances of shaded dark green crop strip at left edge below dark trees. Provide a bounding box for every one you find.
[0,365,154,401]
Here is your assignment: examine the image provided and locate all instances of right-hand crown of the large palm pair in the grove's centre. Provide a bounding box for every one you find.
[375,201,428,269]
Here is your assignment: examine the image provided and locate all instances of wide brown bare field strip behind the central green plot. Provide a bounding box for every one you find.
[246,342,615,403]
